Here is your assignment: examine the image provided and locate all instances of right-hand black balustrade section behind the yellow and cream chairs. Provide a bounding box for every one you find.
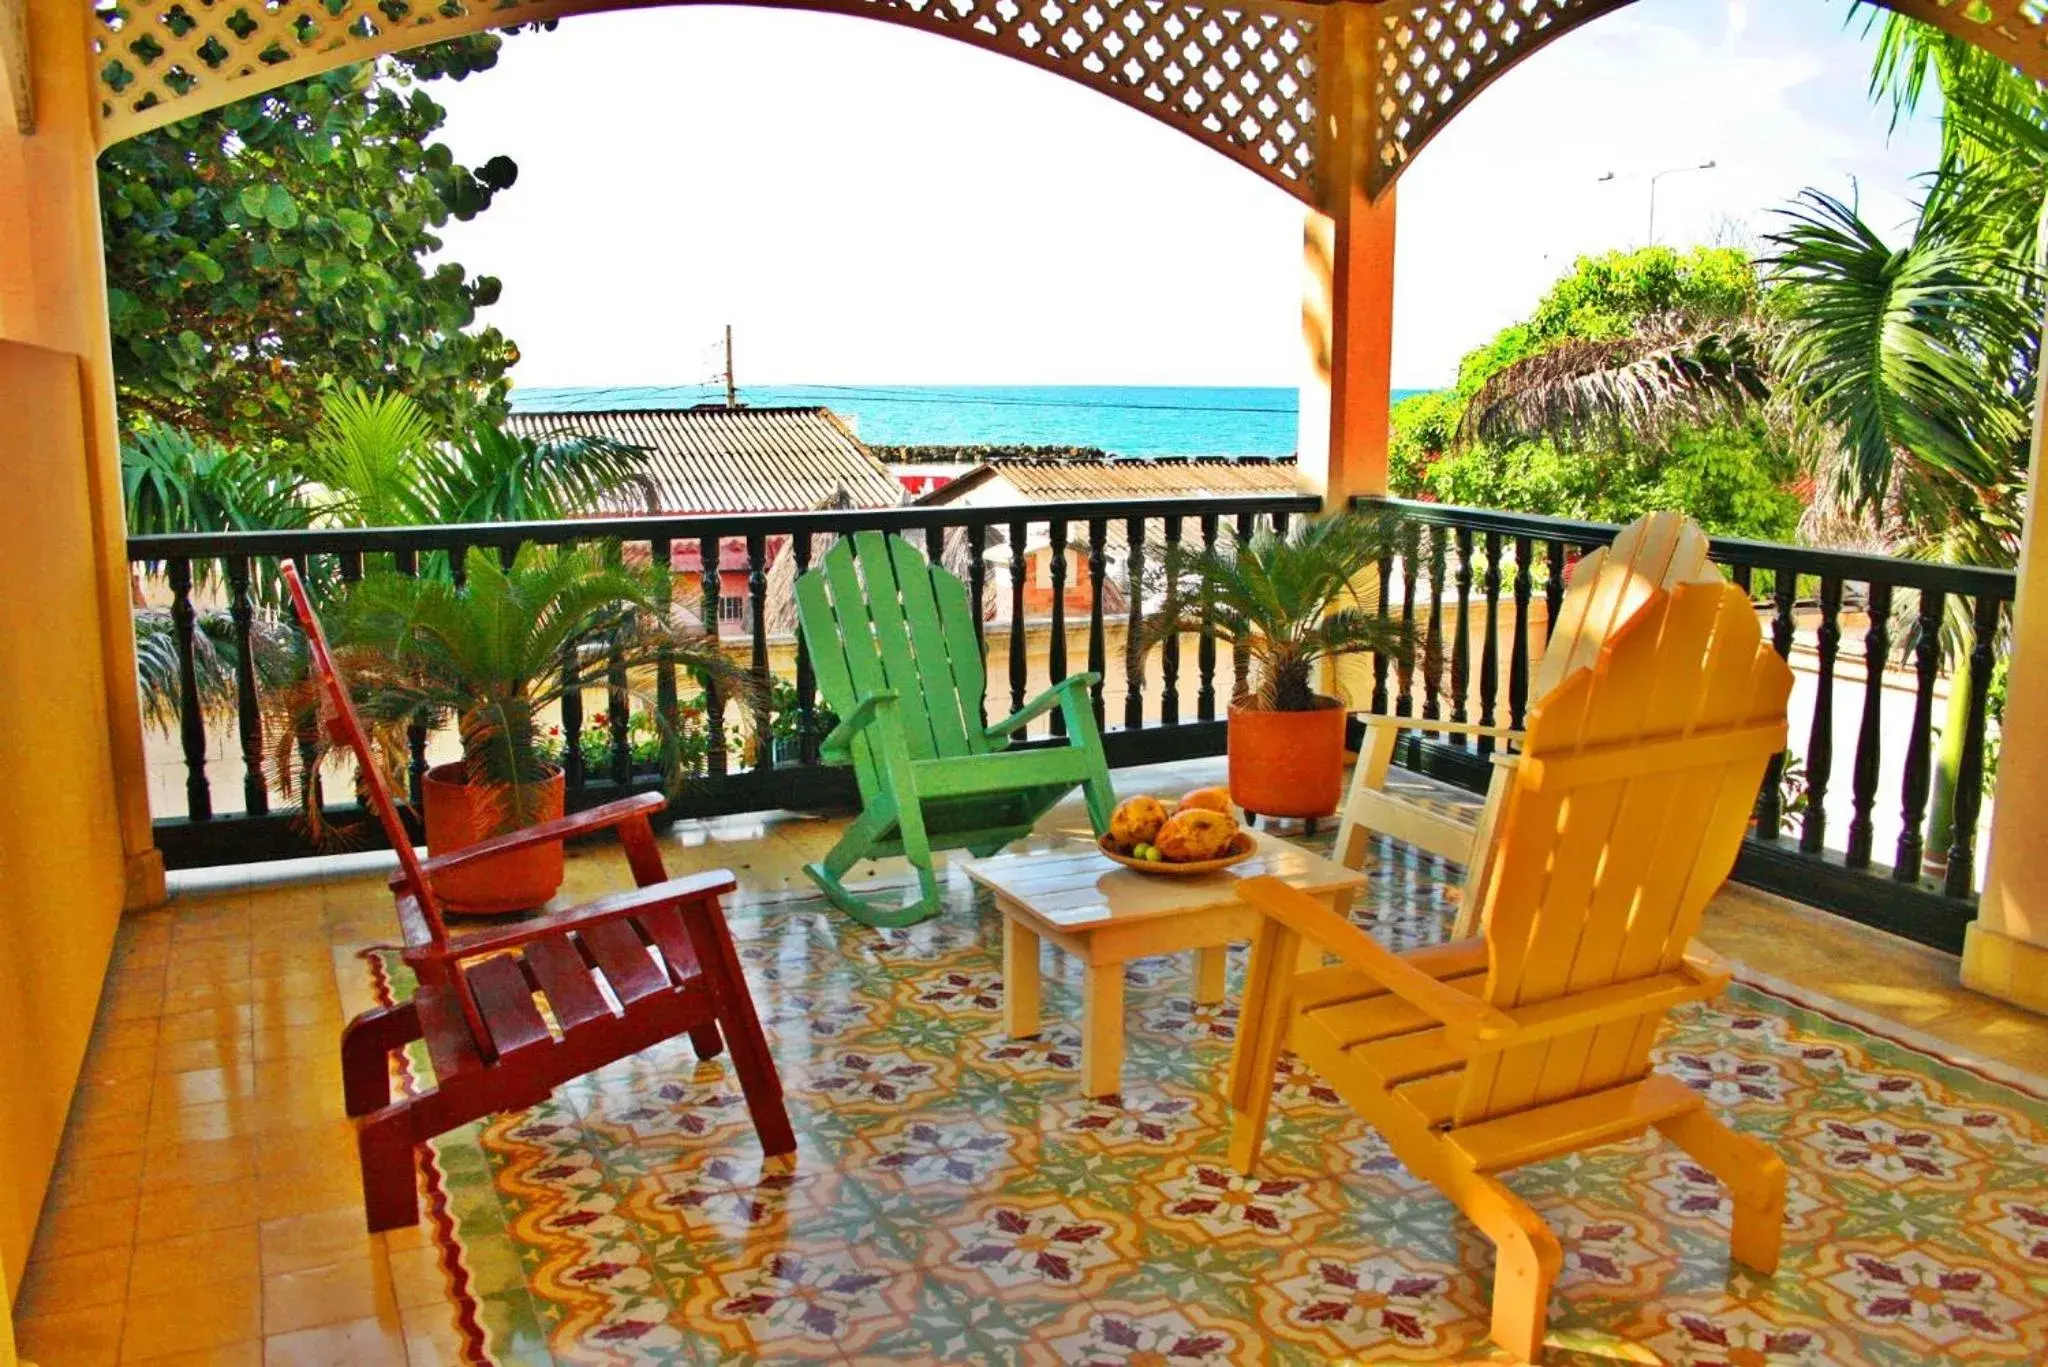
[1354,498,2013,951]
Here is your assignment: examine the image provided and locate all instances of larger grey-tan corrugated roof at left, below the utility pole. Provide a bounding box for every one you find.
[506,406,903,512]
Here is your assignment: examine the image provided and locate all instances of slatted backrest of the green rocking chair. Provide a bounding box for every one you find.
[797,531,989,774]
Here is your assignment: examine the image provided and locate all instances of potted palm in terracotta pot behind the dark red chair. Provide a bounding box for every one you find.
[270,545,752,914]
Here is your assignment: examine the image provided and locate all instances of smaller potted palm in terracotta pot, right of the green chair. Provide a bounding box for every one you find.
[1135,512,1409,820]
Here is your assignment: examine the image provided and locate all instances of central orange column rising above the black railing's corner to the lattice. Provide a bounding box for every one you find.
[1298,0,1395,508]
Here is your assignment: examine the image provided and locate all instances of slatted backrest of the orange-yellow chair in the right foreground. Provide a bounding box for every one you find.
[1456,578,1792,1123]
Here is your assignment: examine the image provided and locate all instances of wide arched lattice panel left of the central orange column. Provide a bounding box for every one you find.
[94,0,1317,197]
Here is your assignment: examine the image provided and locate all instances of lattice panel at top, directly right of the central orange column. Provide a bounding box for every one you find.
[1366,0,1628,195]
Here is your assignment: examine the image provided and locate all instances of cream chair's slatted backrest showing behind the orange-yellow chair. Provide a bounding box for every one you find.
[1530,512,1718,699]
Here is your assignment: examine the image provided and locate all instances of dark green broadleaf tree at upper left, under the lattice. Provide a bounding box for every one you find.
[100,35,518,451]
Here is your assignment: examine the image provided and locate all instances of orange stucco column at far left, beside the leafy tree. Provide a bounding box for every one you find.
[0,0,164,908]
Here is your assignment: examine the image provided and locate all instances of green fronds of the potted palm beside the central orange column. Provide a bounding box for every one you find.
[1133,512,1409,711]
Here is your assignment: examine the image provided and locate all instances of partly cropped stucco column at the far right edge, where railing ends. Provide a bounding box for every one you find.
[1962,352,2048,1012]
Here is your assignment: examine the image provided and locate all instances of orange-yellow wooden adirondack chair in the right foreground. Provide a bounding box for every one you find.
[1229,582,1792,1361]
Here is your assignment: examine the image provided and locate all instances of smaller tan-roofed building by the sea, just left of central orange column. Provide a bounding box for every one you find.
[918,457,1303,619]
